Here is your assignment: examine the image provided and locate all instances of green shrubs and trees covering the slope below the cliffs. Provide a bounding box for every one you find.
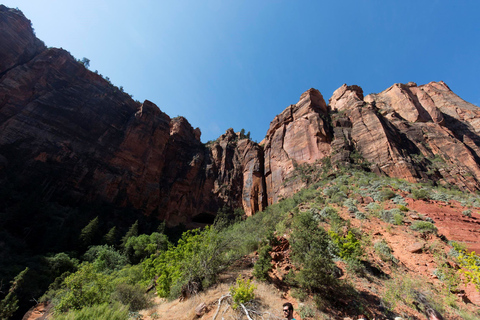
[0,166,480,319]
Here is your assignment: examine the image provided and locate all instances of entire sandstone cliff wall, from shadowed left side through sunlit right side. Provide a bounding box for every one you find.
[0,6,480,225]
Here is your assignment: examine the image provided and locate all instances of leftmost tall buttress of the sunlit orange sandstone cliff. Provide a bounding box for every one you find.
[264,89,333,204]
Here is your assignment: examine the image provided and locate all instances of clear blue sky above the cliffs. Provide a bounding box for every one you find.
[3,0,480,142]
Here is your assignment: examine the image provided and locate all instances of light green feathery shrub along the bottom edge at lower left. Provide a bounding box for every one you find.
[55,302,129,320]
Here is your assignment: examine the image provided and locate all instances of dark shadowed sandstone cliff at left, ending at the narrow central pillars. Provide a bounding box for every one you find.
[0,6,265,225]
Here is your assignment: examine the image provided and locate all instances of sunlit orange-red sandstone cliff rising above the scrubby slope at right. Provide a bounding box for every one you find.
[264,82,480,204]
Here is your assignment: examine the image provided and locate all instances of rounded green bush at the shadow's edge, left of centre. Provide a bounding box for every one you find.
[125,232,168,264]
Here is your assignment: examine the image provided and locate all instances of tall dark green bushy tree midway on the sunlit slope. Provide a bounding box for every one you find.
[290,211,336,291]
